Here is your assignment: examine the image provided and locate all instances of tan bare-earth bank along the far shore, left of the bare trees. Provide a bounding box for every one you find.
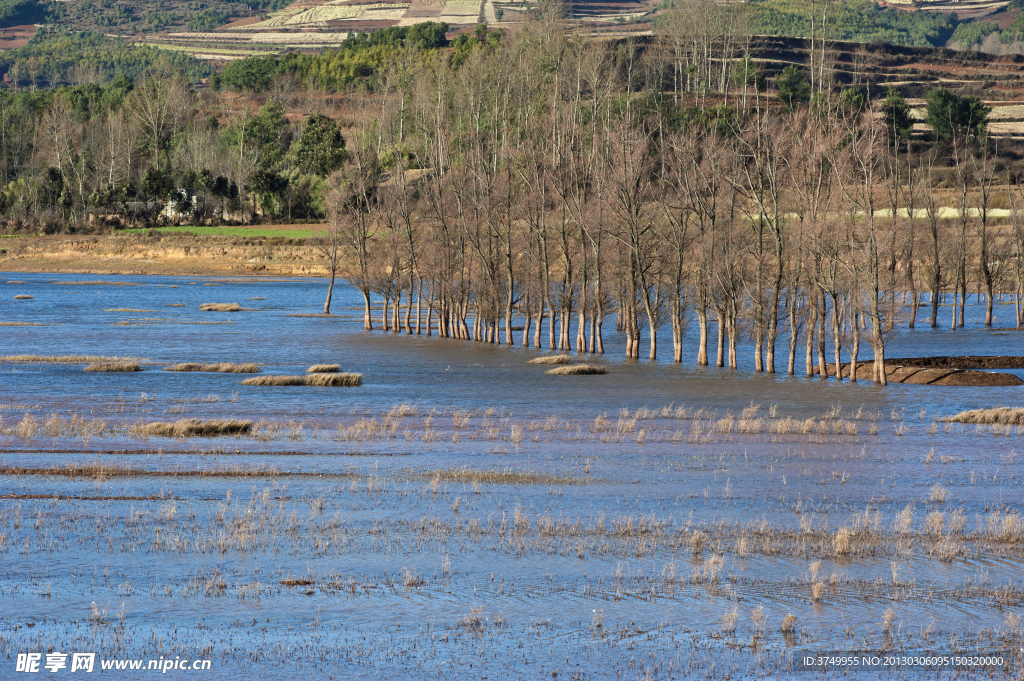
[0,233,326,276]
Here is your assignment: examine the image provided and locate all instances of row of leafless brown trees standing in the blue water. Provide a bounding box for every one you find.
[321,25,1024,382]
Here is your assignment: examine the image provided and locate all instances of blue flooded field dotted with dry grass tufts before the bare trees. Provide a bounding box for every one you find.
[0,273,1024,679]
